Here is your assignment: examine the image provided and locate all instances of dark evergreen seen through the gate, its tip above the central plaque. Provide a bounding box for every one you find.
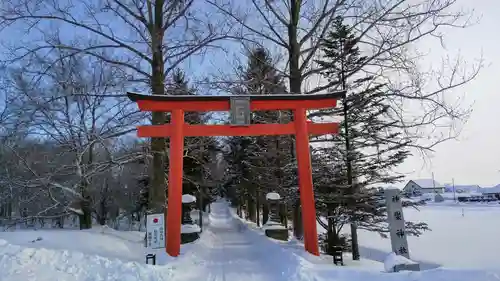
[227,48,291,223]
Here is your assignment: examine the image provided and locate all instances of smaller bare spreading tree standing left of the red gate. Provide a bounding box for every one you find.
[8,50,145,228]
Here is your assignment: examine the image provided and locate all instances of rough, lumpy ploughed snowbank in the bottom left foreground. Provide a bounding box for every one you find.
[0,240,172,281]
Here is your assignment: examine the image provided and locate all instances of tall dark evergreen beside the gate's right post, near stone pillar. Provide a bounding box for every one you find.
[313,17,427,259]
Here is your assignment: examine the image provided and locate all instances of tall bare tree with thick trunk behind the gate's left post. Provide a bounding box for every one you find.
[0,0,234,211]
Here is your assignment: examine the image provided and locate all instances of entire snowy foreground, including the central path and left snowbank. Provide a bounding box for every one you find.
[0,201,500,281]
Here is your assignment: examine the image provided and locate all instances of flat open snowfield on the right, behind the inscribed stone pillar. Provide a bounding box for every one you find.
[359,203,500,270]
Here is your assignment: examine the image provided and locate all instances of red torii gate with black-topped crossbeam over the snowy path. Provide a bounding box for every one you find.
[128,92,345,257]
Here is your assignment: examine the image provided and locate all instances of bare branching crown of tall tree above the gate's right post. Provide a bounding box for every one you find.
[208,0,481,150]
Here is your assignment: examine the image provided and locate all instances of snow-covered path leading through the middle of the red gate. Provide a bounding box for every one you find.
[165,201,316,281]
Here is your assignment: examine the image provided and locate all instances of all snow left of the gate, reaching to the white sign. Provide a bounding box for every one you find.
[0,226,174,281]
